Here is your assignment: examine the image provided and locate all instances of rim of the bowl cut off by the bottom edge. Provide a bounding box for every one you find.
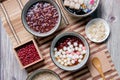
[26,69,61,80]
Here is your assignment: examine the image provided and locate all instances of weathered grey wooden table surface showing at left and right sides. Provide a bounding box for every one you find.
[0,0,120,80]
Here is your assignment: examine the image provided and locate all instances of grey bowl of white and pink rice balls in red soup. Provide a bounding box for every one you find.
[50,32,89,71]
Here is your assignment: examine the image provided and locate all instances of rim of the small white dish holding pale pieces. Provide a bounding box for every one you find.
[85,18,111,43]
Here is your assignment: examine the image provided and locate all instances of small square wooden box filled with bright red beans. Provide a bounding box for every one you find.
[14,39,43,68]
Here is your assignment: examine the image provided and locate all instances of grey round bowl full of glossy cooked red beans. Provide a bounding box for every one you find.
[21,0,61,37]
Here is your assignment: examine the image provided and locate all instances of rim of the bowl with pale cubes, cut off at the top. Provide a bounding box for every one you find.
[61,0,100,17]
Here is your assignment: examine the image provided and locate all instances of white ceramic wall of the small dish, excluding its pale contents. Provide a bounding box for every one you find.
[85,18,110,43]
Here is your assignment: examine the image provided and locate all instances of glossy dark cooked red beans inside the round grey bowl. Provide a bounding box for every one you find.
[26,2,59,33]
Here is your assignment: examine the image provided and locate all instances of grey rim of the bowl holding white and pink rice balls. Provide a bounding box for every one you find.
[50,32,90,71]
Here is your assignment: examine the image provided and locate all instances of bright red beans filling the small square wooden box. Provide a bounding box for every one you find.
[17,43,40,66]
